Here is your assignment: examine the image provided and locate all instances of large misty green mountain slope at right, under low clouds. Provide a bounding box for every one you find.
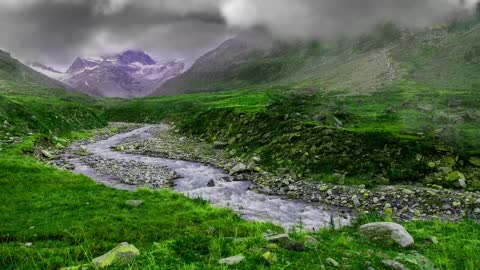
[156,19,480,95]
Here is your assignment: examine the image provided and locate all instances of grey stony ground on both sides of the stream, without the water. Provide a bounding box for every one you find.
[40,122,480,226]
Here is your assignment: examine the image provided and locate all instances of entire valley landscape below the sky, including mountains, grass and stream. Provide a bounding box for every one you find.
[0,6,480,270]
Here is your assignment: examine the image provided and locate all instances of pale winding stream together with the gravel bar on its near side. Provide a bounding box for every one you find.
[47,125,352,230]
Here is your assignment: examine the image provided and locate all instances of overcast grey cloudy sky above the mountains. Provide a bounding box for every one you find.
[0,0,476,68]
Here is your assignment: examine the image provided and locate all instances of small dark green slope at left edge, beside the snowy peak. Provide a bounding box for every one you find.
[0,50,71,90]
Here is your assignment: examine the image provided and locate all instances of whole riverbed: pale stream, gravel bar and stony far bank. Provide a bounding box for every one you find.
[45,125,480,229]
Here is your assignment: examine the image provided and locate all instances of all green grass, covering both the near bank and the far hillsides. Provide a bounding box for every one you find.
[0,16,480,269]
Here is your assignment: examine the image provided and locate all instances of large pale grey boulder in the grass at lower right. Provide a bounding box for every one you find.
[360,222,414,247]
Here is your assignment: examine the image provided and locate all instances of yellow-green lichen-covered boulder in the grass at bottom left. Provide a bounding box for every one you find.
[92,242,140,268]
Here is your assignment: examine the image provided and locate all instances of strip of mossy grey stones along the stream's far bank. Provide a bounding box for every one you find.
[115,123,480,221]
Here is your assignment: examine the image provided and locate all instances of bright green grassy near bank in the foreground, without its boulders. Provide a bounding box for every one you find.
[0,128,480,269]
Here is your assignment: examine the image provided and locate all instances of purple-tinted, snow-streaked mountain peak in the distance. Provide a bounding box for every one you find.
[33,50,185,97]
